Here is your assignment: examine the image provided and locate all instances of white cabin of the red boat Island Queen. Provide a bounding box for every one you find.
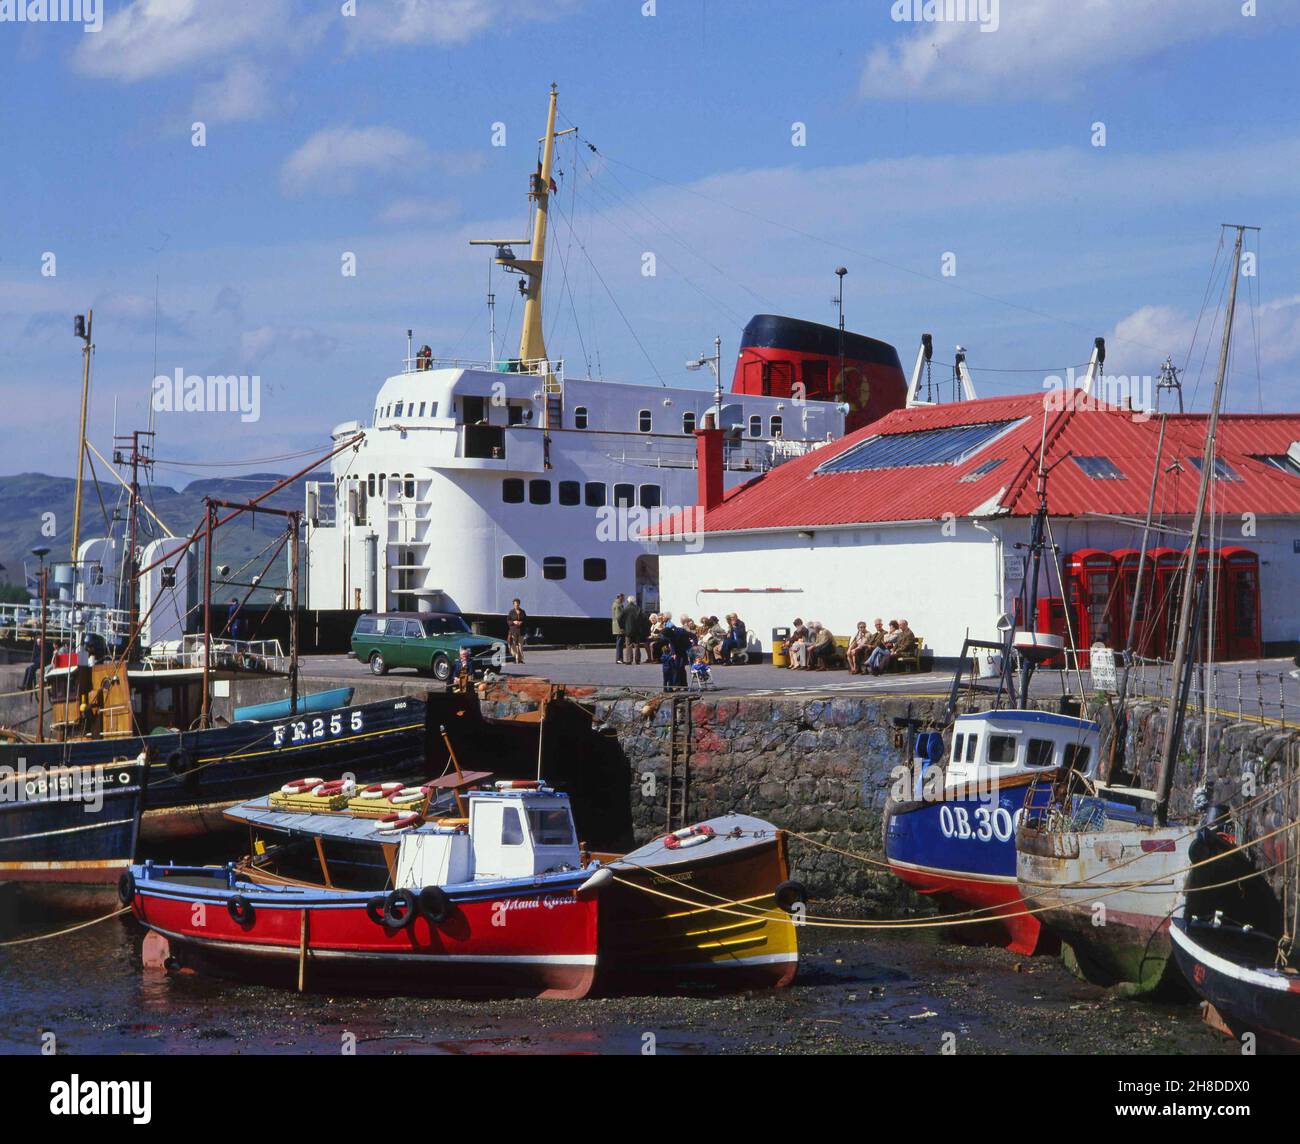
[397,783,582,888]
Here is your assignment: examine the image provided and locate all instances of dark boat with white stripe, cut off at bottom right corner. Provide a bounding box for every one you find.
[1170,915,1300,1053]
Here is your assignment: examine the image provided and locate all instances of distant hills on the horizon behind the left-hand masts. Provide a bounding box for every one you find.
[0,472,328,599]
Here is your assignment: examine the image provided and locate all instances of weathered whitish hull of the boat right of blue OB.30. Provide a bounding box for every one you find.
[1017,826,1193,995]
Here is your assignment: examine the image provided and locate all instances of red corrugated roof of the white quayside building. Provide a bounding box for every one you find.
[659,391,1300,533]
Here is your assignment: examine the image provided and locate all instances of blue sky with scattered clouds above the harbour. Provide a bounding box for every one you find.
[0,0,1300,485]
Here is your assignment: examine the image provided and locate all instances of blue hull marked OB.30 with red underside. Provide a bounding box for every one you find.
[884,783,1056,954]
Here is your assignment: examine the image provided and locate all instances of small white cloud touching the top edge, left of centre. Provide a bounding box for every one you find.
[350,0,582,46]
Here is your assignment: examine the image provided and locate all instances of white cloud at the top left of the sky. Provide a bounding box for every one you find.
[73,0,295,83]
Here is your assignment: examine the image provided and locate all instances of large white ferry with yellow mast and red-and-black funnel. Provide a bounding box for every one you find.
[307,87,907,640]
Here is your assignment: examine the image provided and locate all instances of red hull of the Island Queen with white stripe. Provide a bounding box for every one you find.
[133,867,598,997]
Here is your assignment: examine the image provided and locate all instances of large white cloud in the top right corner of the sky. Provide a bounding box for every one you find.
[861,0,1300,99]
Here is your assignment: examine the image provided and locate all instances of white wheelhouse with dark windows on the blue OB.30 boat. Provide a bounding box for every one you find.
[944,711,1100,788]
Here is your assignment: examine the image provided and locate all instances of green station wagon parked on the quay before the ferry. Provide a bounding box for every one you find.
[352,612,506,683]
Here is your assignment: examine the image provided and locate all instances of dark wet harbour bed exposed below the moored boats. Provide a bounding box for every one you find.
[0,915,1236,1056]
